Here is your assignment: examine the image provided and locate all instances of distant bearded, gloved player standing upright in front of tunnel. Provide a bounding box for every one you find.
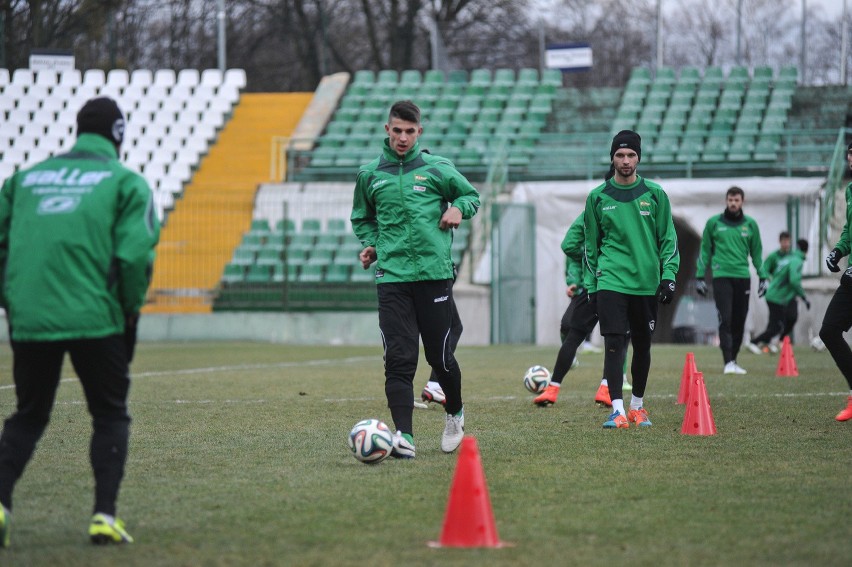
[695,186,769,374]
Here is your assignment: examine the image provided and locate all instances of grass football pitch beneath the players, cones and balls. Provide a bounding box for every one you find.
[0,343,852,567]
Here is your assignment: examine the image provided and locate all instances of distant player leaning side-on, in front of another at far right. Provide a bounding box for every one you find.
[753,239,811,352]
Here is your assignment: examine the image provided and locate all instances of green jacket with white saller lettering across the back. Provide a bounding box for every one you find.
[0,134,160,341]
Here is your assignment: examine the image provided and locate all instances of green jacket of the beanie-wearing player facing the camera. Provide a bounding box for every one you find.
[584,176,680,295]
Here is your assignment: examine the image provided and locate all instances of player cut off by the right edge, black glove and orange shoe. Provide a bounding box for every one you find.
[819,144,852,421]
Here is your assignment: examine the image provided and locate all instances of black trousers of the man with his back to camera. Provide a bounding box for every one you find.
[0,335,130,515]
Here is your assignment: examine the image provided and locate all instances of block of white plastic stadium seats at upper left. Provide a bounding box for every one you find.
[0,69,245,222]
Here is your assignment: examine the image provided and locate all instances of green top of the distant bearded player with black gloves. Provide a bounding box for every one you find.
[695,213,766,279]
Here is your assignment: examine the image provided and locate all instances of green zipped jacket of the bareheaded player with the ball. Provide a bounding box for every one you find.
[350,139,479,283]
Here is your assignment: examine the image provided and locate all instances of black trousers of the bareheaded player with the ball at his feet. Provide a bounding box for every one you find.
[376,279,462,434]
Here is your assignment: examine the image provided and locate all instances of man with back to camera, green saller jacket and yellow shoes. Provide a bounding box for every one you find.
[0,97,159,547]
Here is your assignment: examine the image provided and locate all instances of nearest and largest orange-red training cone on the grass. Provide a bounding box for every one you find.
[429,436,505,547]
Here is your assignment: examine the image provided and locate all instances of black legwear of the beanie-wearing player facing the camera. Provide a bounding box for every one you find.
[597,290,659,400]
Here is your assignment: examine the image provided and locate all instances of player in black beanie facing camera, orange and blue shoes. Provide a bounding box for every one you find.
[584,130,680,429]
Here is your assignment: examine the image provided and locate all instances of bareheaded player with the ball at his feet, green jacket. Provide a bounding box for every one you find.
[351,100,479,458]
